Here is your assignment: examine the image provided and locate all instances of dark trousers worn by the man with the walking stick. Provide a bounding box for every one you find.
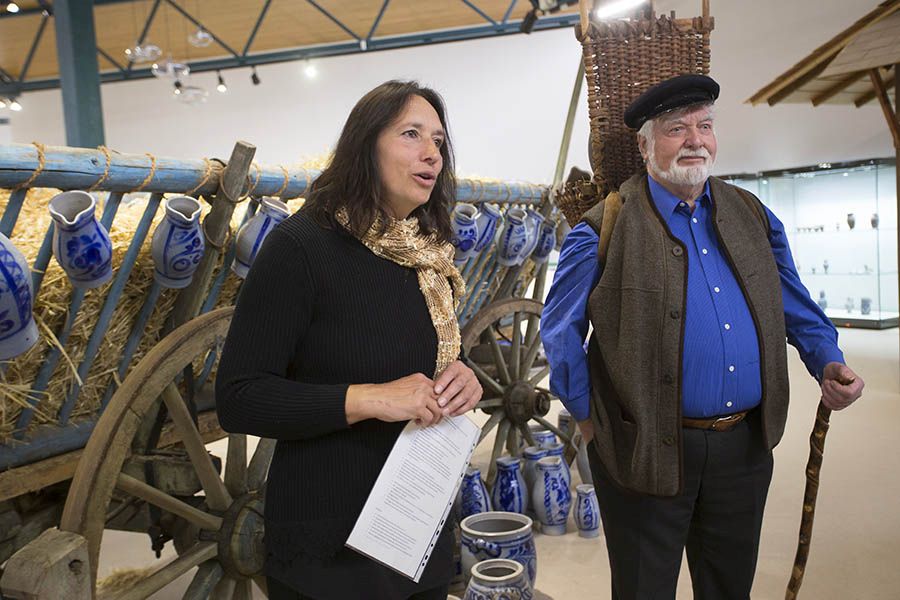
[588,411,772,600]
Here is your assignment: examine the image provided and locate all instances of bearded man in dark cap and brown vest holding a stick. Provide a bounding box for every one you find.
[542,75,863,600]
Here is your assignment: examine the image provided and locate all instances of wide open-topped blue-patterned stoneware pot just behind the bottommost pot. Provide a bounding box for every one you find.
[460,511,537,586]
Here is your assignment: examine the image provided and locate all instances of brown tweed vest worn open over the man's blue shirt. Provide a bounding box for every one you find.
[583,174,789,496]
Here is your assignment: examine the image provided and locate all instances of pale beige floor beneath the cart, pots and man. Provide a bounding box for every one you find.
[101,329,900,600]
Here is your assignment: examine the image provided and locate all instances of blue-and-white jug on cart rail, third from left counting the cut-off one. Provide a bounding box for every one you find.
[150,196,205,289]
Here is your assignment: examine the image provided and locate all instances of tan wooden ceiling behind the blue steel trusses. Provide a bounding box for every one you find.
[0,0,578,91]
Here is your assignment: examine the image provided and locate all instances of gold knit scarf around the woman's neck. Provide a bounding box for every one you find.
[337,209,466,379]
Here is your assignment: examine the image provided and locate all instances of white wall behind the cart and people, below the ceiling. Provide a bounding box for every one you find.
[5,0,893,182]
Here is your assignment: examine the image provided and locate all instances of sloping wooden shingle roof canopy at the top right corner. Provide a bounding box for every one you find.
[747,0,900,107]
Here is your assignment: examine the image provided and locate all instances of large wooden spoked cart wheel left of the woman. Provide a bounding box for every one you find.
[60,307,274,600]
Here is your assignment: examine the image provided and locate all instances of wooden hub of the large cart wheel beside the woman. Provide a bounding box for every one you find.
[219,494,266,577]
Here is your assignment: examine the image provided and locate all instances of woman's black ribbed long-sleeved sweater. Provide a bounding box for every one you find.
[216,211,452,600]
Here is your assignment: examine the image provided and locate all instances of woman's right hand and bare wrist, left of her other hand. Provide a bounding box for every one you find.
[346,373,441,427]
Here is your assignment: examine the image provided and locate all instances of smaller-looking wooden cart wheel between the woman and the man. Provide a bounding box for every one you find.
[461,298,574,485]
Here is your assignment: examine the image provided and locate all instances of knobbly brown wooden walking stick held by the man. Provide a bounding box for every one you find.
[784,372,855,600]
